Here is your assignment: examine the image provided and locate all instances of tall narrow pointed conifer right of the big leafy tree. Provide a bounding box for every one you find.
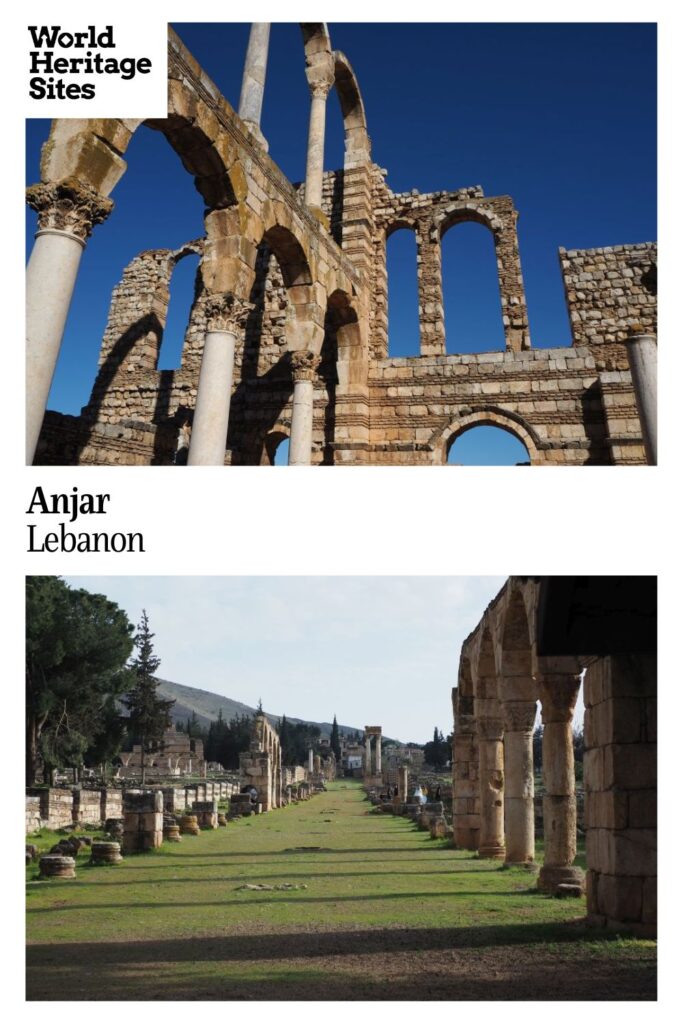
[124,609,175,785]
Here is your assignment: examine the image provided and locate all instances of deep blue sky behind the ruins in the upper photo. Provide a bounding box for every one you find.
[27,24,656,462]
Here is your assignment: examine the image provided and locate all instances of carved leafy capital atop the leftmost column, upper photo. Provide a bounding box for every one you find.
[26,178,114,242]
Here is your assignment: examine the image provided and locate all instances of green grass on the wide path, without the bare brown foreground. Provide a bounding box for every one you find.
[28,782,652,997]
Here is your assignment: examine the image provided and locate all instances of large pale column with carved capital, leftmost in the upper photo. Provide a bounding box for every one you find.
[26,178,114,465]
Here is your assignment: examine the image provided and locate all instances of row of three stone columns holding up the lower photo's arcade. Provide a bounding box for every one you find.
[454,675,583,891]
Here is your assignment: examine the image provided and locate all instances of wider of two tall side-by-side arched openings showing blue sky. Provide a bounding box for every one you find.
[441,221,505,354]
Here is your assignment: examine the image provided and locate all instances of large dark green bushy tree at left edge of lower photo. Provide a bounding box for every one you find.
[26,577,133,785]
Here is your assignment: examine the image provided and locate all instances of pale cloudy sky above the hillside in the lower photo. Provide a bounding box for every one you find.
[65,577,506,743]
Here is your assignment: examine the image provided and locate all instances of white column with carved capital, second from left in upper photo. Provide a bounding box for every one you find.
[187,295,249,466]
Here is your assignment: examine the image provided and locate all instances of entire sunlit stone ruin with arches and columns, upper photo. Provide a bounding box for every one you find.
[27,24,656,466]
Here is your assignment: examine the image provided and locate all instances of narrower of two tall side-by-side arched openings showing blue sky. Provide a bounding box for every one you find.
[386,227,420,357]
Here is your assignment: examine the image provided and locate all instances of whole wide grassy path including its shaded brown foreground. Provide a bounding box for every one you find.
[28,782,654,999]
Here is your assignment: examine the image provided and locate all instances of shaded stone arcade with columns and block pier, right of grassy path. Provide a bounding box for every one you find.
[453,577,656,935]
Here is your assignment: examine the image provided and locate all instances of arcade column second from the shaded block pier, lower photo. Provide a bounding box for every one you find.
[503,700,536,864]
